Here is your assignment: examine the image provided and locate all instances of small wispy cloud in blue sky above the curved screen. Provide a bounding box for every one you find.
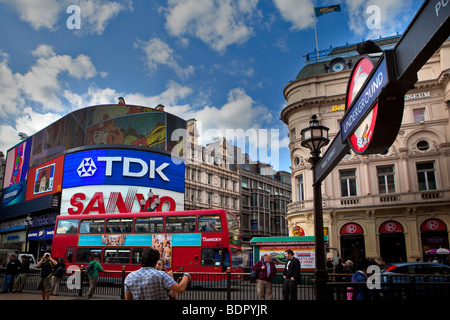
[134,37,194,79]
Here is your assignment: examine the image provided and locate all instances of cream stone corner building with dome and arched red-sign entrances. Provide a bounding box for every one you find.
[281,36,450,262]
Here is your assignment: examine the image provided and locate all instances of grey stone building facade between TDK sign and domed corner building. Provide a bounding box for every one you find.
[184,119,291,252]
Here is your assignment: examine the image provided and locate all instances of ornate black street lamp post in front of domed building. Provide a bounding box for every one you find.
[301,114,330,300]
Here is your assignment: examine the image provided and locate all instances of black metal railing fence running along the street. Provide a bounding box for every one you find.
[0,270,450,301]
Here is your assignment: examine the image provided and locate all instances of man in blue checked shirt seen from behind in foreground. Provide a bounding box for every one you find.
[125,249,191,300]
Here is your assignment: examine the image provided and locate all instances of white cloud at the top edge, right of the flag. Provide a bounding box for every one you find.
[345,0,412,39]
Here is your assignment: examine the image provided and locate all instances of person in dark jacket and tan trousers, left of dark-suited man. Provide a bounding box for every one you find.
[252,253,277,300]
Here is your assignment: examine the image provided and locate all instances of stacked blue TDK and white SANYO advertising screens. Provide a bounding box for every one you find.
[61,149,185,215]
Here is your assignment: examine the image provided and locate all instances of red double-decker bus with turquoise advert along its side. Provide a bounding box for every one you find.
[52,210,242,272]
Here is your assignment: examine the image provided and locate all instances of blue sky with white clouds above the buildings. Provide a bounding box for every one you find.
[0,0,422,171]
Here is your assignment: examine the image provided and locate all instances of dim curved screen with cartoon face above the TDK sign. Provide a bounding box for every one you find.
[30,105,186,166]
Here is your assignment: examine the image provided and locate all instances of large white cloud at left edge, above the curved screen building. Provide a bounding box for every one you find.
[0,45,97,151]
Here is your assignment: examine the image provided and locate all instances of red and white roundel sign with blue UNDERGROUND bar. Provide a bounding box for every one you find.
[341,51,403,154]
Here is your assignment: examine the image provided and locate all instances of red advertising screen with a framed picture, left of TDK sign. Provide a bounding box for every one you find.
[26,156,64,201]
